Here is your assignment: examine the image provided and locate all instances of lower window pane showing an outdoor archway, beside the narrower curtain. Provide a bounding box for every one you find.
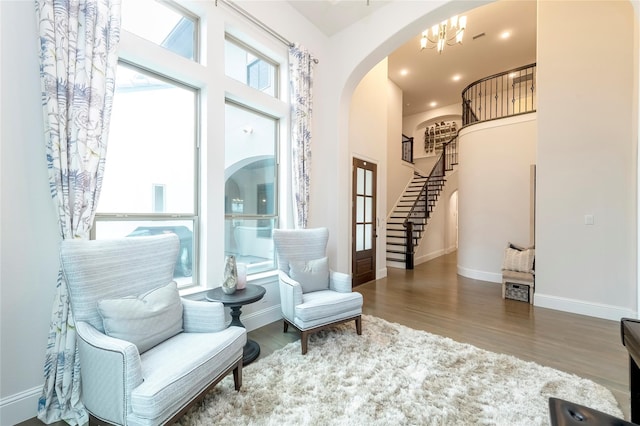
[225,101,278,273]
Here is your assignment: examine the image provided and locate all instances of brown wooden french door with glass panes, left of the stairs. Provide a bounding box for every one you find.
[351,158,377,286]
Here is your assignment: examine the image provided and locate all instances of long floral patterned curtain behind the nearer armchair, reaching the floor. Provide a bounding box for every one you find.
[36,0,120,425]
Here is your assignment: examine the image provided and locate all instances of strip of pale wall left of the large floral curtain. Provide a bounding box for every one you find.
[0,1,60,425]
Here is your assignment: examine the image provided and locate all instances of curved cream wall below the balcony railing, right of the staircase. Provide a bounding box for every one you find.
[458,113,538,282]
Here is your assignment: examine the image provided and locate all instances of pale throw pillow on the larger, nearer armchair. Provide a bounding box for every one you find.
[98,281,182,353]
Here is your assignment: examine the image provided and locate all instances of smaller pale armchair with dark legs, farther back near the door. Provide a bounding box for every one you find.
[273,228,362,354]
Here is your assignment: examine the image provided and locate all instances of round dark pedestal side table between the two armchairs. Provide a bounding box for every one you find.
[205,284,267,365]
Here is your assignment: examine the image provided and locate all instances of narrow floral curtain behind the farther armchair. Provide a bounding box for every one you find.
[289,44,315,228]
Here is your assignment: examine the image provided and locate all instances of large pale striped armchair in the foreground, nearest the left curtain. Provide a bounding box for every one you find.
[60,234,246,426]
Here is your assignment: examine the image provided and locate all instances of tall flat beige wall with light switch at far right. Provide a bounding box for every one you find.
[536,1,638,320]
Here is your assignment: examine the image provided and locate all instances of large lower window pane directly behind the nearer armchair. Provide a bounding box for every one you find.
[94,63,199,286]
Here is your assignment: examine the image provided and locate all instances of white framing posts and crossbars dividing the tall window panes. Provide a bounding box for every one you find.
[107,0,293,296]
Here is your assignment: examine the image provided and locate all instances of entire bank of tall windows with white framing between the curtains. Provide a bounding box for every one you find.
[106,0,290,291]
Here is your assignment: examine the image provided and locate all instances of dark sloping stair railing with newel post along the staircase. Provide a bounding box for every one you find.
[403,134,458,269]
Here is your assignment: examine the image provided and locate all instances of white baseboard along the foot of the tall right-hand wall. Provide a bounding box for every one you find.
[533,292,637,321]
